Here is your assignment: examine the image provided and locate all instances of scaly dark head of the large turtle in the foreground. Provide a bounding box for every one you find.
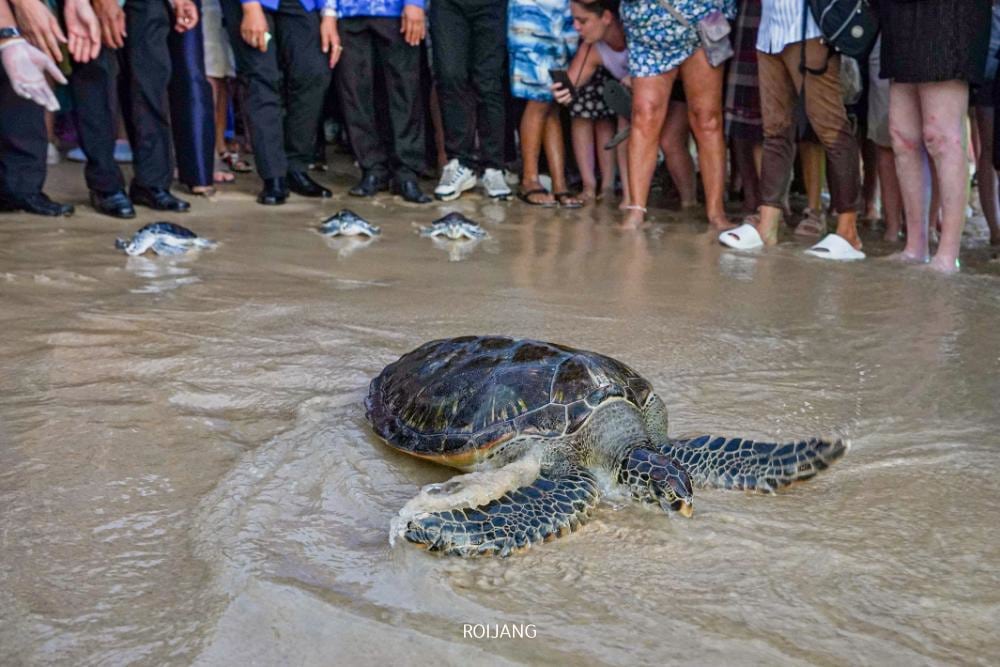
[618,447,694,517]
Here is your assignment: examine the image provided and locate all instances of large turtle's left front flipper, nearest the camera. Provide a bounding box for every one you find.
[398,465,600,557]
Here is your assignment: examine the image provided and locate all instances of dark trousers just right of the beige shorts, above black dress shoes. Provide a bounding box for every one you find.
[219,0,330,178]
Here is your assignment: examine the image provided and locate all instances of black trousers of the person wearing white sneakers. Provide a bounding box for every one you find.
[430,0,507,169]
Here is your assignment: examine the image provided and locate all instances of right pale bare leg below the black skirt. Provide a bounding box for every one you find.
[917,81,969,273]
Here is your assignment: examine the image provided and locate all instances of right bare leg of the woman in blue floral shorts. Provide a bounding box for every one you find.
[680,49,733,230]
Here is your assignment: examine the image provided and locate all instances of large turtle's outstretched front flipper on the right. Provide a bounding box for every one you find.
[659,435,849,493]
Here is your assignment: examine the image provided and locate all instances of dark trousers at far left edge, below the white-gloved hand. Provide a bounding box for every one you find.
[0,67,49,197]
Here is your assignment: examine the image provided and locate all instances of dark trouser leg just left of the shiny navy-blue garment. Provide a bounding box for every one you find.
[123,0,180,188]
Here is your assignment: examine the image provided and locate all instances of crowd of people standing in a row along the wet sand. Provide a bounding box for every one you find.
[0,0,1000,273]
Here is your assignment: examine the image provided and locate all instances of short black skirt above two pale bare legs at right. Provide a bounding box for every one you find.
[879,0,992,84]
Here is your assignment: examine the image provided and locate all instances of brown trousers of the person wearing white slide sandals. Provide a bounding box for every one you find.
[757,38,861,213]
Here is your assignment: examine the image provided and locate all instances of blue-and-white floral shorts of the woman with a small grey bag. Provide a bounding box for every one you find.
[621,0,736,77]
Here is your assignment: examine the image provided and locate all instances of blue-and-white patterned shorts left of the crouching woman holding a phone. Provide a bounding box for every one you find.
[507,0,578,102]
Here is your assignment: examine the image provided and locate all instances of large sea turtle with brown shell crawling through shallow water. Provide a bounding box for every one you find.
[365,336,848,556]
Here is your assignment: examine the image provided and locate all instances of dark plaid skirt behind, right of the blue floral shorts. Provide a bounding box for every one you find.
[725,0,764,141]
